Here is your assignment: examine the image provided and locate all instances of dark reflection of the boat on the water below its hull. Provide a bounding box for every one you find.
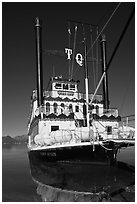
[29,149,135,202]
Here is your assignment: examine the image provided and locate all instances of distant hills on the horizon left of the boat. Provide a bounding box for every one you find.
[2,135,28,144]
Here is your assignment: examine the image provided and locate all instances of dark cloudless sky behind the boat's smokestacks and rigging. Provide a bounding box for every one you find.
[2,2,135,136]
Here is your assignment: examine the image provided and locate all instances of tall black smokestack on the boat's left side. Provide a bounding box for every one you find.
[35,17,43,107]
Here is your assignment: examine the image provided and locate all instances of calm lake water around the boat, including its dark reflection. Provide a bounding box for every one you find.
[2,145,135,202]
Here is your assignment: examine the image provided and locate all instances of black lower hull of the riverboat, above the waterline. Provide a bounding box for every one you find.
[29,145,116,163]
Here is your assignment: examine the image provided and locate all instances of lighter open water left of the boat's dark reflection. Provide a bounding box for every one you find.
[2,145,35,202]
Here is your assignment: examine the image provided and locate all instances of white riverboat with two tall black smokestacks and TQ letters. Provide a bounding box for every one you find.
[28,15,135,164]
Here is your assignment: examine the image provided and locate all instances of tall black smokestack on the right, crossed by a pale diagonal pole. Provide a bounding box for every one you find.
[100,35,109,109]
